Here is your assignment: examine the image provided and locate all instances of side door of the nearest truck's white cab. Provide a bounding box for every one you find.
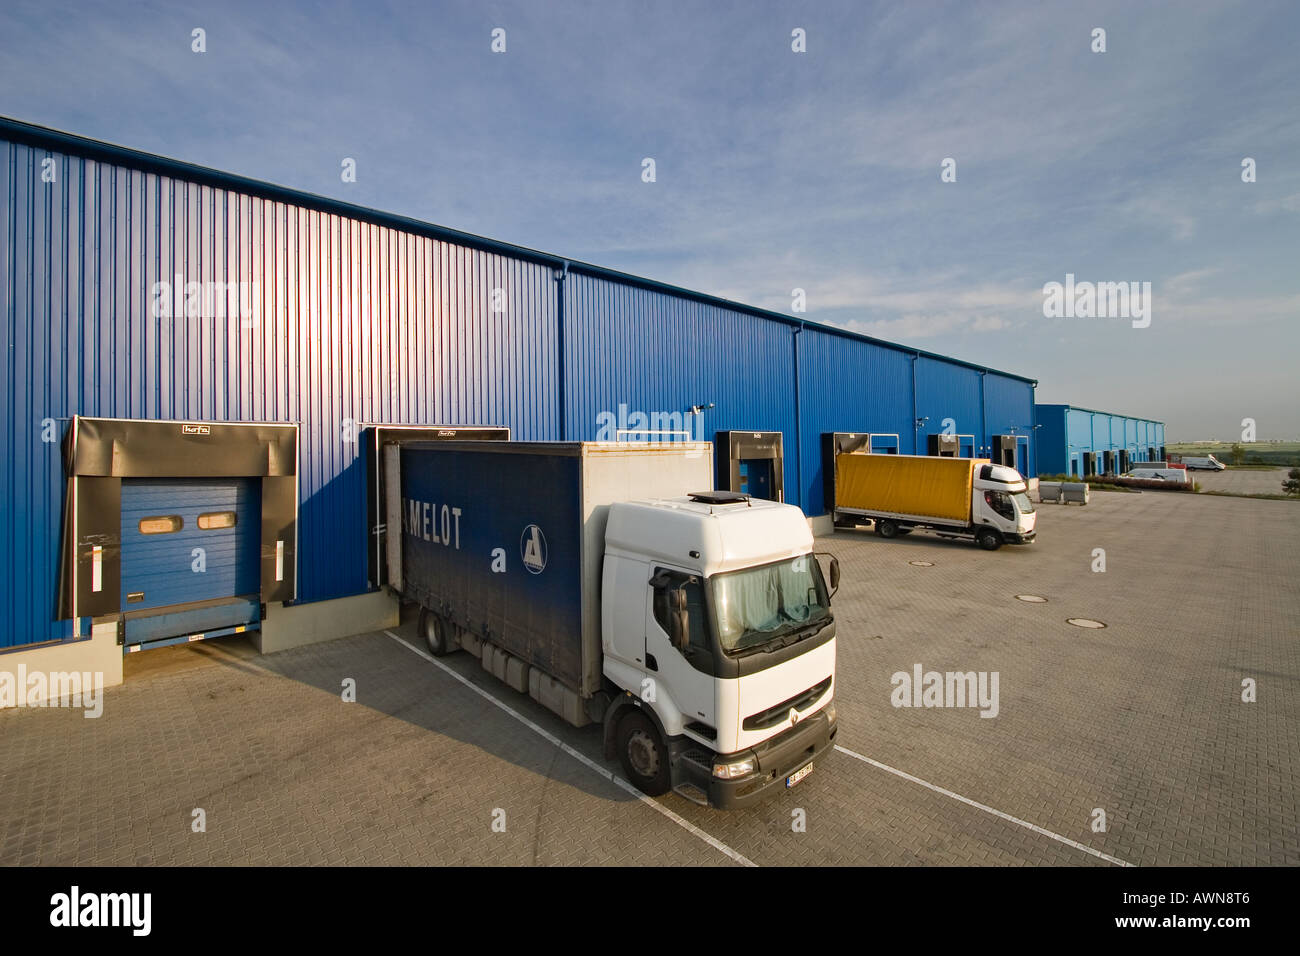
[646,564,718,745]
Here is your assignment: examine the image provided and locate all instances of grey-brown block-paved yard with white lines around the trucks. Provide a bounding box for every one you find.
[0,493,1300,866]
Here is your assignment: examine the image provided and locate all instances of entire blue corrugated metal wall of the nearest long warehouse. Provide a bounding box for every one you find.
[0,125,1034,646]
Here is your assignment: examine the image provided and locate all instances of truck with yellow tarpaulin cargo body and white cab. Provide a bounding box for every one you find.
[828,454,1037,551]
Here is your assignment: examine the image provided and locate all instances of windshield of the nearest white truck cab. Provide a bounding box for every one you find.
[711,554,831,653]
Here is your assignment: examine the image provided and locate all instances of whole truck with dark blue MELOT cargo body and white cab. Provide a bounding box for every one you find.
[384,441,840,808]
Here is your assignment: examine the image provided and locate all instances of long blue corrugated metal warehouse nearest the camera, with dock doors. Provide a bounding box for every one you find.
[0,120,1036,686]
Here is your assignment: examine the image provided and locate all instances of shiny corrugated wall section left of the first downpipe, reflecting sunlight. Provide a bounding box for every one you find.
[0,140,558,645]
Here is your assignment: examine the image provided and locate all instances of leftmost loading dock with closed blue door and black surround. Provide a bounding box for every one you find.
[59,416,298,653]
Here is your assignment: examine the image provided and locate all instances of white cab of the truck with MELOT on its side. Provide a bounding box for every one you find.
[601,492,839,808]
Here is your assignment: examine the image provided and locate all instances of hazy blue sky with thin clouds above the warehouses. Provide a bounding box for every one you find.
[0,0,1300,441]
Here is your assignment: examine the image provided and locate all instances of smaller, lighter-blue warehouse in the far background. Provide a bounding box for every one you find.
[1034,405,1165,477]
